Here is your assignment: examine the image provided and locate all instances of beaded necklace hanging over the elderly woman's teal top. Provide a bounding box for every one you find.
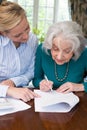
[54,62,69,82]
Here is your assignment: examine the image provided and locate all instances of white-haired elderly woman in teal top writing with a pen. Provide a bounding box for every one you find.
[33,21,87,93]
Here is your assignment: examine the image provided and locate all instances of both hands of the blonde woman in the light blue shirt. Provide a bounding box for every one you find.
[0,80,40,102]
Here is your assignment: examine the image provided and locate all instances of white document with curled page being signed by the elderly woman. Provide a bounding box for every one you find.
[34,90,79,113]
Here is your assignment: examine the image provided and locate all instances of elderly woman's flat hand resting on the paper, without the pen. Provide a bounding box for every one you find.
[56,82,84,93]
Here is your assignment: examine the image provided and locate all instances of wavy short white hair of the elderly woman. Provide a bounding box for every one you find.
[42,21,87,60]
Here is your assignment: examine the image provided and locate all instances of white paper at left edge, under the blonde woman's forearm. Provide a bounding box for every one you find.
[0,98,31,116]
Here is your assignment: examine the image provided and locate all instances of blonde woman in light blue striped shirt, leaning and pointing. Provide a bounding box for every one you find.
[0,0,38,102]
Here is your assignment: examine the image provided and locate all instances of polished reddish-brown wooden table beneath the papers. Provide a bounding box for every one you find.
[0,92,87,130]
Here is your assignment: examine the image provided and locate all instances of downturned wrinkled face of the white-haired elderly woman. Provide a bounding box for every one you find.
[51,37,73,65]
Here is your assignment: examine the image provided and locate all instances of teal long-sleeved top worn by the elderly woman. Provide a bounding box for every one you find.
[33,45,87,92]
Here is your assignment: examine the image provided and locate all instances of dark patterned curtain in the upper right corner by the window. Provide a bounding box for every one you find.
[69,0,87,38]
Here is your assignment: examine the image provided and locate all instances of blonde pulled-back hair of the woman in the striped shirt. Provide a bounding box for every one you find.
[0,0,26,32]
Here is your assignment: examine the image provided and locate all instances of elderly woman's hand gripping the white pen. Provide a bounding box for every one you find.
[39,79,53,91]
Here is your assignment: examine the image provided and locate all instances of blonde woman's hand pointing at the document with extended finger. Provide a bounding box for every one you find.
[7,87,40,102]
